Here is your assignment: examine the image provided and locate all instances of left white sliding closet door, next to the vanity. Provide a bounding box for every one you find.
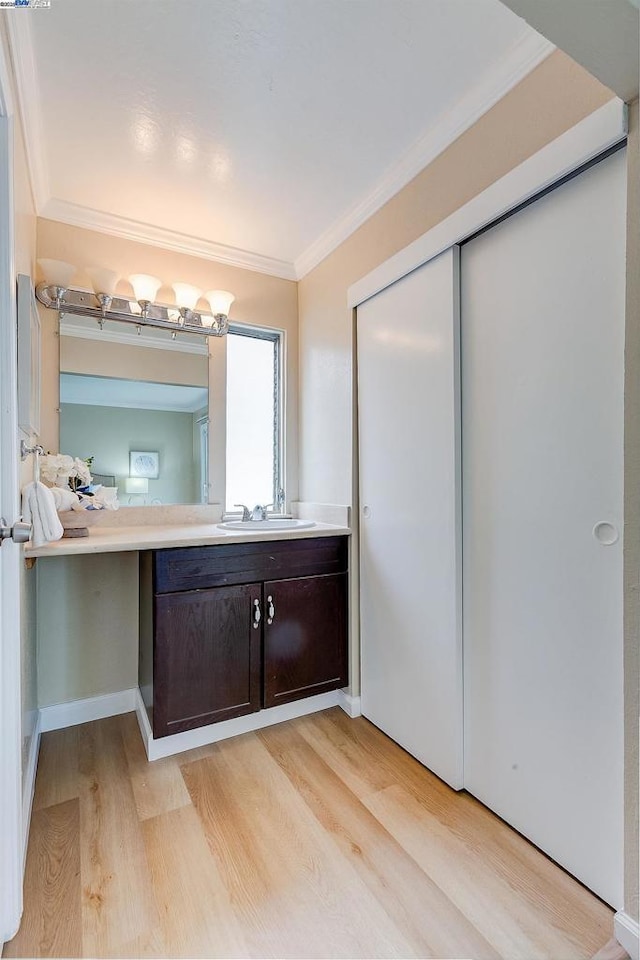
[358,248,462,788]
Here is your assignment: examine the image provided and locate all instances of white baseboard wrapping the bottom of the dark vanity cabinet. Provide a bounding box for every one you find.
[136,690,348,760]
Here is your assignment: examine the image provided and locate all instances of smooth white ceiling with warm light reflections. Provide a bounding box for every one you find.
[10,0,552,278]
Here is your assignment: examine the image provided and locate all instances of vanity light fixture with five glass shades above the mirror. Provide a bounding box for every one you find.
[36,260,235,338]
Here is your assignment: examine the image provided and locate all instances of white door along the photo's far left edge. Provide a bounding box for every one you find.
[0,31,24,943]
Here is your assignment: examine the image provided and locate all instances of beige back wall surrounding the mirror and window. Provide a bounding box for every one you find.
[33,219,298,510]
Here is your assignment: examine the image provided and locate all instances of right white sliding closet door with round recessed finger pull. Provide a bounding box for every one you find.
[461,152,626,907]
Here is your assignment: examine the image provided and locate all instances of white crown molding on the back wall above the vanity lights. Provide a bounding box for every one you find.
[40,197,297,280]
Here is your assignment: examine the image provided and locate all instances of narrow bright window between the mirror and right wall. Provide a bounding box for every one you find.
[226,328,282,512]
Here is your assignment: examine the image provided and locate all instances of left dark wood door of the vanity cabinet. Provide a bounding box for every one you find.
[153,584,262,737]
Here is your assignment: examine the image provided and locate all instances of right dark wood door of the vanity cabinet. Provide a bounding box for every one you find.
[264,573,347,707]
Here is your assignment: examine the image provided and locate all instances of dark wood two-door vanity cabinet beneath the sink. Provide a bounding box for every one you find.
[140,537,348,737]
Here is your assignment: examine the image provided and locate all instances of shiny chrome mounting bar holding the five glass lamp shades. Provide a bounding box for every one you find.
[36,283,226,337]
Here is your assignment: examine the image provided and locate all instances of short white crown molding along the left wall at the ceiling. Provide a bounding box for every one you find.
[5,12,50,214]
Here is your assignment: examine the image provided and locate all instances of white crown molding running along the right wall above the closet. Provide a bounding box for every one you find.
[295,28,556,280]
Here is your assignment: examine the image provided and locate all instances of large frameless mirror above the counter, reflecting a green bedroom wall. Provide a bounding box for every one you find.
[60,317,209,506]
